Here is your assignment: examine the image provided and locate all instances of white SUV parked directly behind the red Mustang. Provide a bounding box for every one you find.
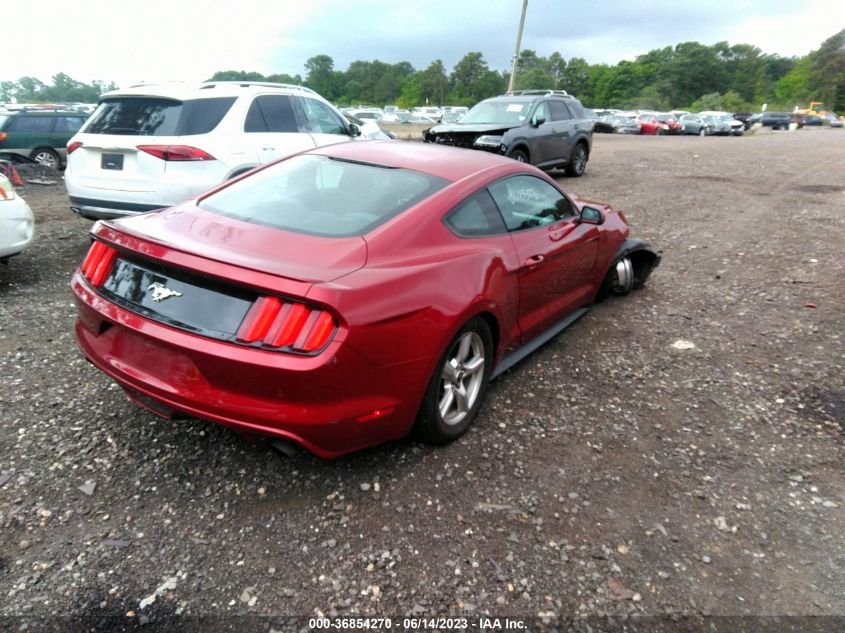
[65,81,360,219]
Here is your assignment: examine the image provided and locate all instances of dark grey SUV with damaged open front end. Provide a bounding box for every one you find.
[423,90,593,176]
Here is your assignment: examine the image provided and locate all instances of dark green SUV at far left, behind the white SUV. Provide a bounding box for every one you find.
[0,110,88,169]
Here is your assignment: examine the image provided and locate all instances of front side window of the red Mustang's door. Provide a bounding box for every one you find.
[489,176,575,231]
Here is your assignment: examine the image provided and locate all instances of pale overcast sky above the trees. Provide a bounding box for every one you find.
[6,0,845,86]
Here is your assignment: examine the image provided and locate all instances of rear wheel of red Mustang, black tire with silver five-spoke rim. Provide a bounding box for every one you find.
[414,317,493,444]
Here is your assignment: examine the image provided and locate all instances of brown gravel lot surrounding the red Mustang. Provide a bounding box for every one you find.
[0,128,845,631]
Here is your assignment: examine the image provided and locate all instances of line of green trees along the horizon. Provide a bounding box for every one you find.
[0,29,845,112]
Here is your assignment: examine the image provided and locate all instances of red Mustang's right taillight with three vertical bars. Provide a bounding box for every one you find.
[237,297,337,352]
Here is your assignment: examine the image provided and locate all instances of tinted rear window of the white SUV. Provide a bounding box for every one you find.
[82,97,235,136]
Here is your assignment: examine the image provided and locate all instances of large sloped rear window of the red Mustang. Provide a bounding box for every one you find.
[199,155,448,237]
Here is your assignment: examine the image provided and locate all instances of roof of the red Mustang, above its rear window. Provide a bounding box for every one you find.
[306,140,519,182]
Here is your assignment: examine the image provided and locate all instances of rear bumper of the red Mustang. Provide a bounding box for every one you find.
[72,273,429,457]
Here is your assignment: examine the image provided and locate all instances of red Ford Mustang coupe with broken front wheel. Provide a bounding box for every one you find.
[72,141,660,457]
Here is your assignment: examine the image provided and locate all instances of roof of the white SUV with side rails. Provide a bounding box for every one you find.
[100,81,318,101]
